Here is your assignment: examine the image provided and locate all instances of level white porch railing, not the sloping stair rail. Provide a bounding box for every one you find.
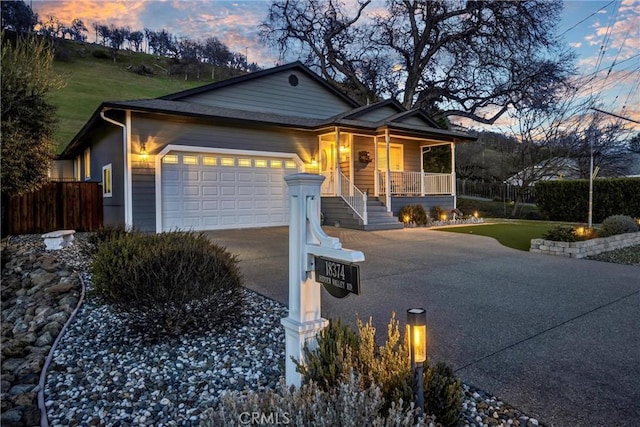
[376,171,453,196]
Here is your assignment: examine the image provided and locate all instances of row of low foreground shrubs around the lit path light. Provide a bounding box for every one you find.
[210,315,462,427]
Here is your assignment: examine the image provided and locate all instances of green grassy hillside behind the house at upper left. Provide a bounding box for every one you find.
[49,40,241,153]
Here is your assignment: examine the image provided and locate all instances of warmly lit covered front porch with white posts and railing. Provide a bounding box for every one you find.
[308,126,456,225]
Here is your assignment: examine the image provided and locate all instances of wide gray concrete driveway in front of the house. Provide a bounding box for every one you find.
[208,227,640,426]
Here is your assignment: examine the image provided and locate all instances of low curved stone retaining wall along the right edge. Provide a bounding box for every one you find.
[529,232,640,258]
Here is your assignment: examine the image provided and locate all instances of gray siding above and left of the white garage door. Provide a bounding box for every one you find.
[131,115,318,231]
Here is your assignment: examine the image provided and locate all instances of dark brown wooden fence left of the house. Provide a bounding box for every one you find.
[3,182,102,235]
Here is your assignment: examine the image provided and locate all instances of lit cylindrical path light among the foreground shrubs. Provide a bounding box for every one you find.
[407,308,427,417]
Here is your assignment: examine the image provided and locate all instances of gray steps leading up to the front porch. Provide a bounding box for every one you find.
[321,197,404,231]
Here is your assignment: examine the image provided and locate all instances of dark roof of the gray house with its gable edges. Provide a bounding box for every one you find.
[59,62,476,158]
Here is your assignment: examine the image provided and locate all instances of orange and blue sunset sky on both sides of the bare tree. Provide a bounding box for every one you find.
[27,0,640,129]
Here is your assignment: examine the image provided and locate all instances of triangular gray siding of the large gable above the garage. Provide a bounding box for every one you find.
[182,70,353,118]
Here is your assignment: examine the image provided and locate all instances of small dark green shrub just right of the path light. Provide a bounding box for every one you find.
[424,362,462,427]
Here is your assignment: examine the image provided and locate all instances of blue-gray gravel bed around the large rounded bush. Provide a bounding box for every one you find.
[3,235,539,427]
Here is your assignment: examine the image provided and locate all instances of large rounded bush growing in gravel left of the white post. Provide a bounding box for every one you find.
[91,232,243,336]
